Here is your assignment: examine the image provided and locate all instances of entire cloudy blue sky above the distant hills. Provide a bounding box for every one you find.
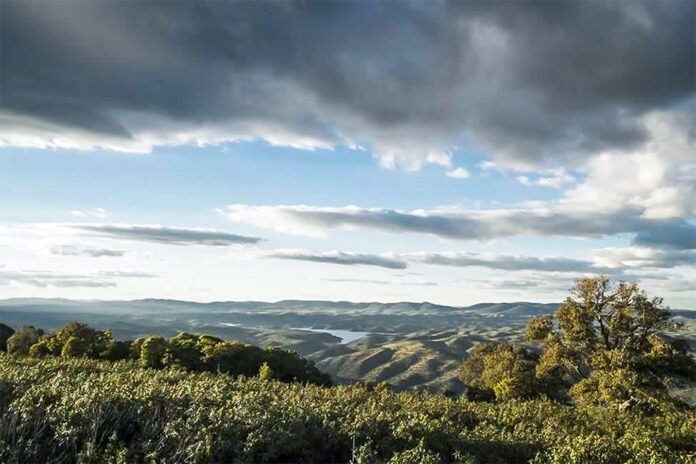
[0,0,696,309]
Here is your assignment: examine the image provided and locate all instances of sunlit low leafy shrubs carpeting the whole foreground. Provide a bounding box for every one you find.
[0,355,696,463]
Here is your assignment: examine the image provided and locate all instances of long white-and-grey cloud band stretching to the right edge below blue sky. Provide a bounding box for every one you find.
[224,203,696,248]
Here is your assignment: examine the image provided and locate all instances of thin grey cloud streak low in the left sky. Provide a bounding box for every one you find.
[71,224,262,246]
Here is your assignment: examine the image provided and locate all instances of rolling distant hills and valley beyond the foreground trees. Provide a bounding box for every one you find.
[0,298,696,393]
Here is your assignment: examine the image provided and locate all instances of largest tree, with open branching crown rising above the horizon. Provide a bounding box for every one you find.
[527,276,696,405]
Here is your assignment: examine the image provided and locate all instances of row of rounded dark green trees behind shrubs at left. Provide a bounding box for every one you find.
[0,322,331,386]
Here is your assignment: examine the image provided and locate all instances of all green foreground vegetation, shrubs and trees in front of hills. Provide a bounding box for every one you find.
[0,277,696,464]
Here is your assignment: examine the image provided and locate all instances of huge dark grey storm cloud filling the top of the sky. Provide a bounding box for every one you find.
[0,0,696,164]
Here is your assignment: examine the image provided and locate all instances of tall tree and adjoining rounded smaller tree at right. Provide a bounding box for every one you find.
[461,277,696,412]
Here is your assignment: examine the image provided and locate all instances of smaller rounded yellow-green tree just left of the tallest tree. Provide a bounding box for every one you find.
[460,343,541,400]
